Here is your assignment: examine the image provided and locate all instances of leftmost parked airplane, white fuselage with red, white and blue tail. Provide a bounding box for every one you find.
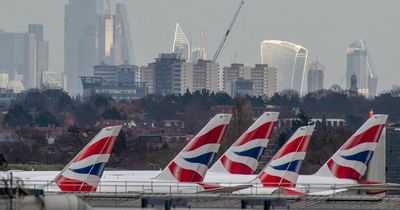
[3,125,122,191]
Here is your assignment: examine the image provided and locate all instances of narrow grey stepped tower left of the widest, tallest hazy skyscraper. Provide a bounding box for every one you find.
[28,24,49,88]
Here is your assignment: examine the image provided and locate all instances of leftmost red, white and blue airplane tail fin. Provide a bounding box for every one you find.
[54,125,122,192]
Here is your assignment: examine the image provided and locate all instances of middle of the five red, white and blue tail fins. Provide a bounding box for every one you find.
[209,112,279,174]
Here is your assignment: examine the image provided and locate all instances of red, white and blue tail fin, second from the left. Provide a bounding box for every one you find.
[155,114,232,182]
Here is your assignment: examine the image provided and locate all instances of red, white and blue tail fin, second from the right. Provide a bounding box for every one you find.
[257,125,314,187]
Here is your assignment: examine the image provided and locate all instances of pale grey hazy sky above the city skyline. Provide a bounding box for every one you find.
[0,0,400,91]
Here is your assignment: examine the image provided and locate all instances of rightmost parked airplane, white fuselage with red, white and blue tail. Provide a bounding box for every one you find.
[298,114,392,195]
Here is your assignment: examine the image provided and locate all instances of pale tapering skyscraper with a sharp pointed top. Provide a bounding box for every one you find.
[172,23,191,61]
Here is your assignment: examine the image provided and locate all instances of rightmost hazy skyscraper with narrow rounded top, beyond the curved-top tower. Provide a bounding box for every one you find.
[346,39,378,97]
